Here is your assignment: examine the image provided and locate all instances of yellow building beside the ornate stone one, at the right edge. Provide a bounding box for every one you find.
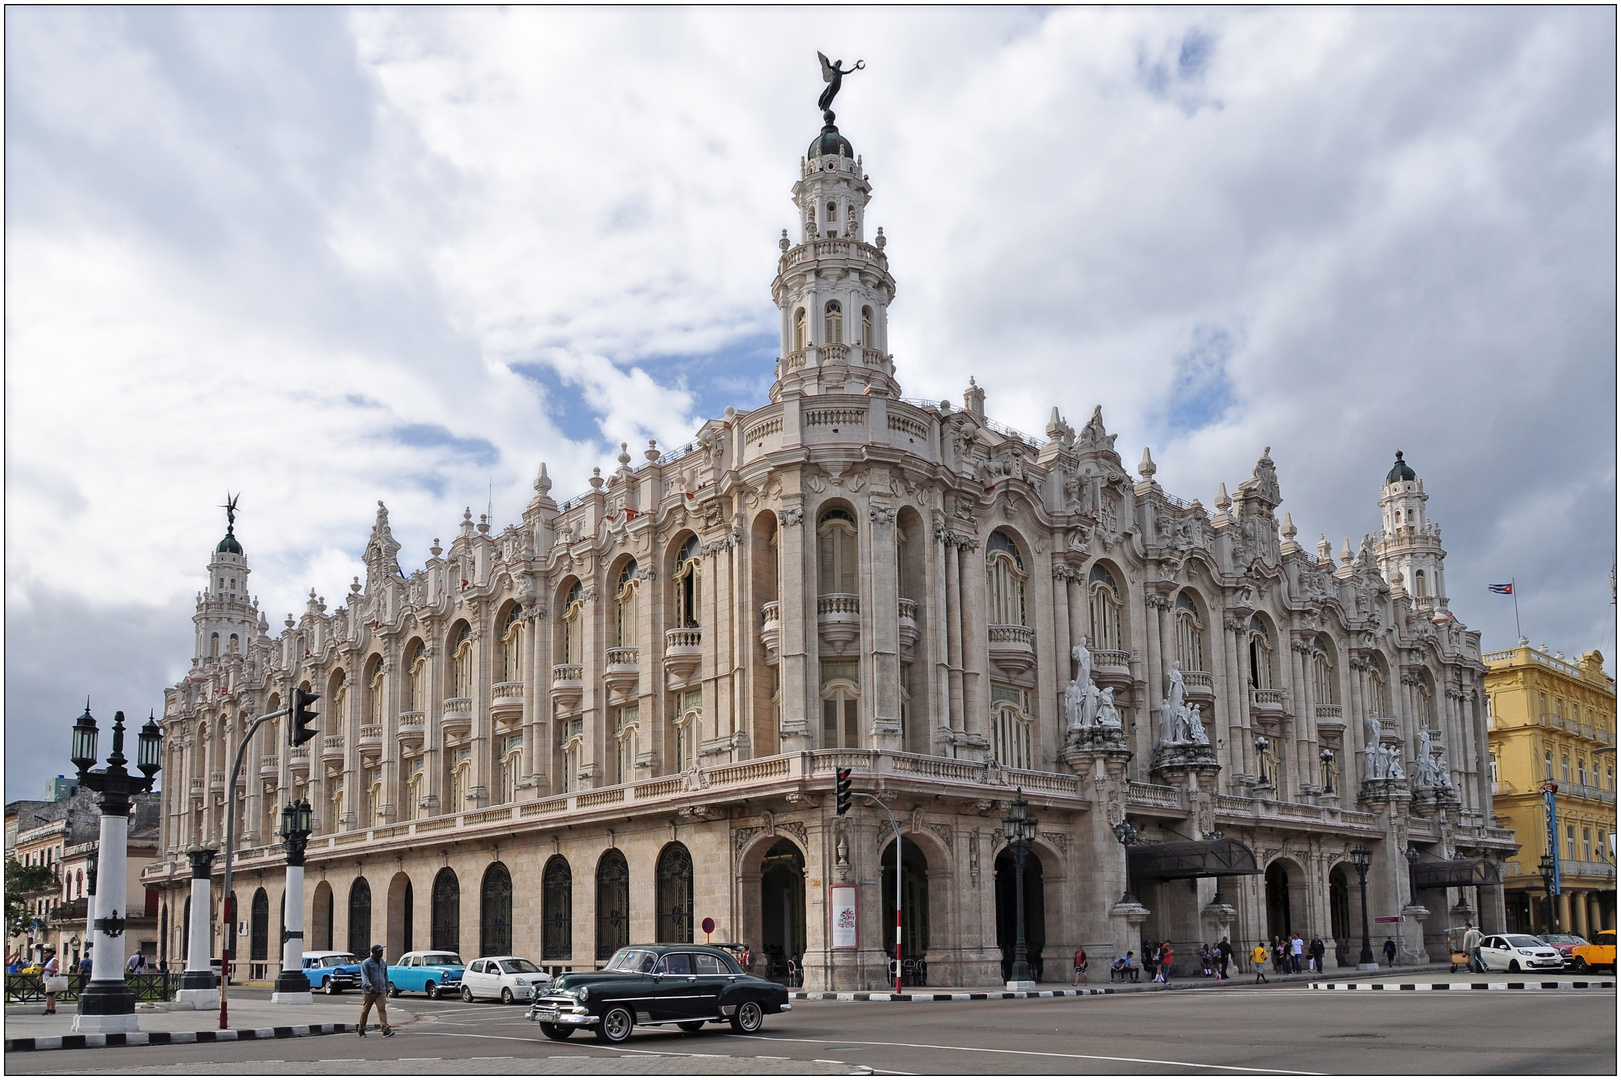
[1483,637,1616,937]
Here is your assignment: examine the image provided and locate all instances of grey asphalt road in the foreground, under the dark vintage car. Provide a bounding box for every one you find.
[5,986,1616,1077]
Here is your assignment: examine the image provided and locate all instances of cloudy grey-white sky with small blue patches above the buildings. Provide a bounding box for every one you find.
[5,6,1616,798]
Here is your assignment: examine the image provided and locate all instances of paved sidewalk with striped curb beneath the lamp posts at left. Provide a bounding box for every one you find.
[5,986,417,1052]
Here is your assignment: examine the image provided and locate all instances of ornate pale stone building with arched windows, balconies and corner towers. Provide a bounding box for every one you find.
[146,98,1514,989]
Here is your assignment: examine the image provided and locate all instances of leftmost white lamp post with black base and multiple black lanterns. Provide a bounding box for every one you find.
[71,704,164,1031]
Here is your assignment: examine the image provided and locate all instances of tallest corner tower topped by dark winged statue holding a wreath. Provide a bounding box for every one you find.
[772,68,900,401]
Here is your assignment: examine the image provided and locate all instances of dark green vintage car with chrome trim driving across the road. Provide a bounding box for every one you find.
[528,945,793,1043]
